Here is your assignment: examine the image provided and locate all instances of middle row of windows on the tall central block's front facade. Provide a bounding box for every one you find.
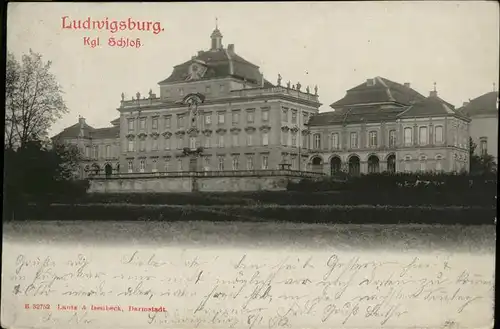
[127,132,269,152]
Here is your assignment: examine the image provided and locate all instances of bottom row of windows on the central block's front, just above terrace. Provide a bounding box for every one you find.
[128,155,269,173]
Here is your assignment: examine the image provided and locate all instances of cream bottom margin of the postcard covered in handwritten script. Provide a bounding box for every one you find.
[2,245,494,329]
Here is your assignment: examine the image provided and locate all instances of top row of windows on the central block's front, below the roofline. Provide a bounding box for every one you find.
[128,109,269,132]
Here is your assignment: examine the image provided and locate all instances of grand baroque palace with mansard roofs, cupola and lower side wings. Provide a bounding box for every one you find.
[53,28,471,176]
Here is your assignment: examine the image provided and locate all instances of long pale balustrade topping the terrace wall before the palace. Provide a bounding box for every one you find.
[89,169,326,179]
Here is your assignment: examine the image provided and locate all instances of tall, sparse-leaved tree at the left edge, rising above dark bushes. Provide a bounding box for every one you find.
[4,49,68,149]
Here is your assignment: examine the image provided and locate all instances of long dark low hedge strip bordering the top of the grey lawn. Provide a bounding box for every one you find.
[10,204,496,225]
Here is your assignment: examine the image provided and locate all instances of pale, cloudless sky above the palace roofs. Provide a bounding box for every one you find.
[7,1,499,135]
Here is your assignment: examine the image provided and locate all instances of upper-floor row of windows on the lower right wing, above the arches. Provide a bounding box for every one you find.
[313,126,444,149]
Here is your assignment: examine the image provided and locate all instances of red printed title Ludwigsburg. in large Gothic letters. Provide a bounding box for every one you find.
[61,16,164,34]
